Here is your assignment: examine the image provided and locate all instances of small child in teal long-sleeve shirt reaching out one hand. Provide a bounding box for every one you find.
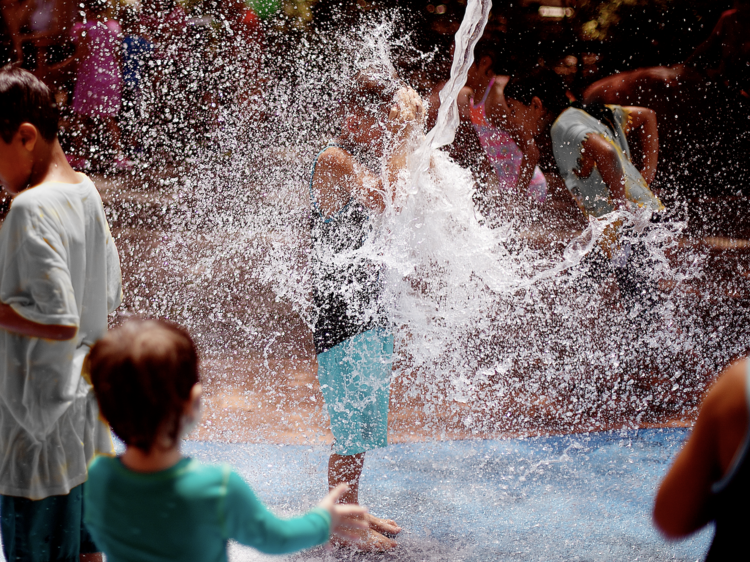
[84,321,367,562]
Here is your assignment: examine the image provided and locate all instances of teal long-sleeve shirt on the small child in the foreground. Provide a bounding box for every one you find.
[84,457,331,562]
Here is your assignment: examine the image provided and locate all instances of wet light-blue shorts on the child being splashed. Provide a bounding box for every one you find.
[318,328,393,455]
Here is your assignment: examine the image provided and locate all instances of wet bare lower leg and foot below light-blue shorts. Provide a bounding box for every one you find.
[328,453,401,551]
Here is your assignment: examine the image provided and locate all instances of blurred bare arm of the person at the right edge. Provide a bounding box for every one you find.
[654,361,747,538]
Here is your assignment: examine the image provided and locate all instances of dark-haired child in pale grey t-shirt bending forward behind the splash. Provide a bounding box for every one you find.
[502,68,664,315]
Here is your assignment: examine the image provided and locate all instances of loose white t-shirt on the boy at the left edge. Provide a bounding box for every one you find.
[0,175,122,499]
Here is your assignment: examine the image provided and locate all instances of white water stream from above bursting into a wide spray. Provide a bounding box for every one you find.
[108,0,739,439]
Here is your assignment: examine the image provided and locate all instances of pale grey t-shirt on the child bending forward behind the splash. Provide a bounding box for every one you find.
[550,105,664,217]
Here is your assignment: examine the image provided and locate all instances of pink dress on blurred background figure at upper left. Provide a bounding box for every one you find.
[72,20,122,117]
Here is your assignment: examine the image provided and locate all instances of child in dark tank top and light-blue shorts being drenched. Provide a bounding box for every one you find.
[310,71,424,551]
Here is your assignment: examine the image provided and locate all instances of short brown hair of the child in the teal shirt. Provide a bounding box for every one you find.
[89,320,200,452]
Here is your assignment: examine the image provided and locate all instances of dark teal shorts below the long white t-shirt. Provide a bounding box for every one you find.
[0,484,100,562]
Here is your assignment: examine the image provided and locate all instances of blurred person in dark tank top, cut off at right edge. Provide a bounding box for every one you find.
[654,359,750,562]
